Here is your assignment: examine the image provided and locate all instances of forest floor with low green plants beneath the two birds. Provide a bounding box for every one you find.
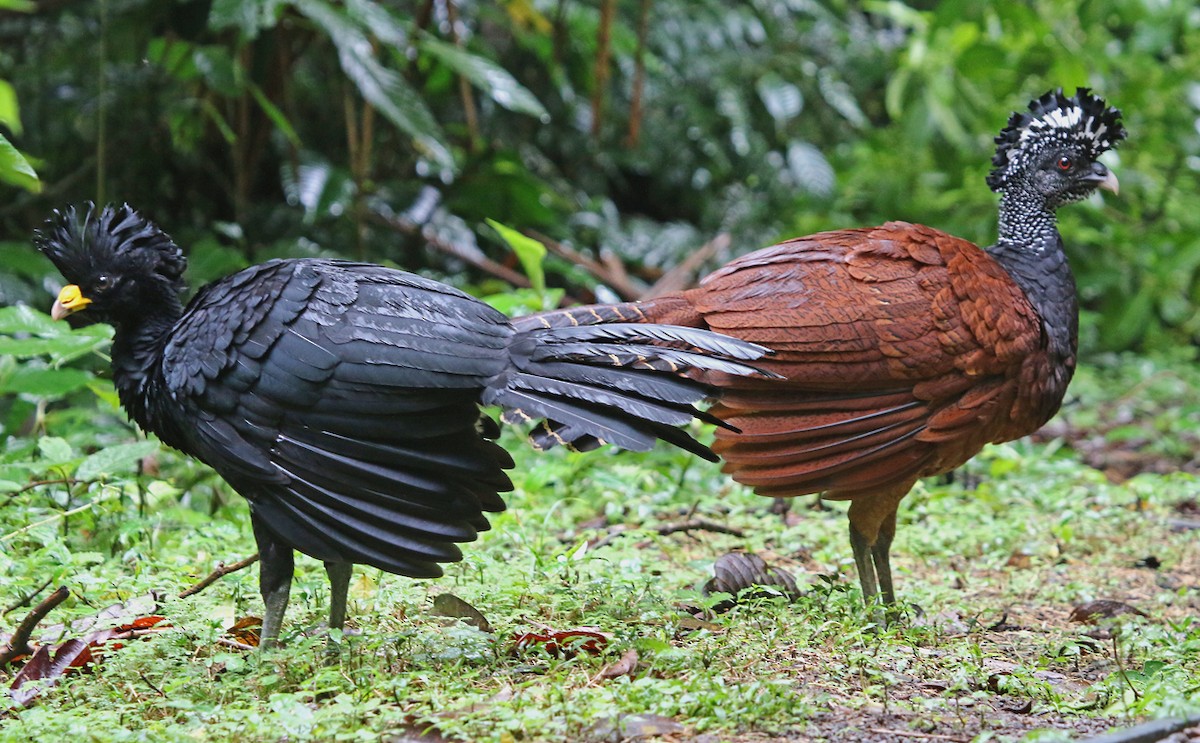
[0,356,1200,743]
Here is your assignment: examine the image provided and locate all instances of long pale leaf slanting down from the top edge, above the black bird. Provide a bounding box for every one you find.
[295,0,455,170]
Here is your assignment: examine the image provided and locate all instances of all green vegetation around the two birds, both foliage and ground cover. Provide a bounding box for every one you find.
[0,0,1200,739]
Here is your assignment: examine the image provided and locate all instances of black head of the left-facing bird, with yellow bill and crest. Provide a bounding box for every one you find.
[34,203,187,324]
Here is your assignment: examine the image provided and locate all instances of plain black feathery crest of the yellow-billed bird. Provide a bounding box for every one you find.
[34,202,187,287]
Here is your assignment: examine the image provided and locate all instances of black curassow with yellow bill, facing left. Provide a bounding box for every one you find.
[36,205,766,646]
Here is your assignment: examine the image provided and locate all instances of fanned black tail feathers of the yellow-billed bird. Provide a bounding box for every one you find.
[484,305,772,461]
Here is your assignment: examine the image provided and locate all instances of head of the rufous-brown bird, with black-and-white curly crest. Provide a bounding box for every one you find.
[988,88,1126,209]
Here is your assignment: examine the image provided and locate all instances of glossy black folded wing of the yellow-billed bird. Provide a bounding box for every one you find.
[156,260,512,576]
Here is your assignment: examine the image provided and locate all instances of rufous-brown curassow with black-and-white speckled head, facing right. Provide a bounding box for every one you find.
[516,89,1124,604]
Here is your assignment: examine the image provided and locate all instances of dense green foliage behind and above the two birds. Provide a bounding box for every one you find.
[0,0,1200,350]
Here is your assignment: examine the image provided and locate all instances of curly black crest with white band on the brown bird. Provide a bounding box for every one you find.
[988,88,1126,191]
